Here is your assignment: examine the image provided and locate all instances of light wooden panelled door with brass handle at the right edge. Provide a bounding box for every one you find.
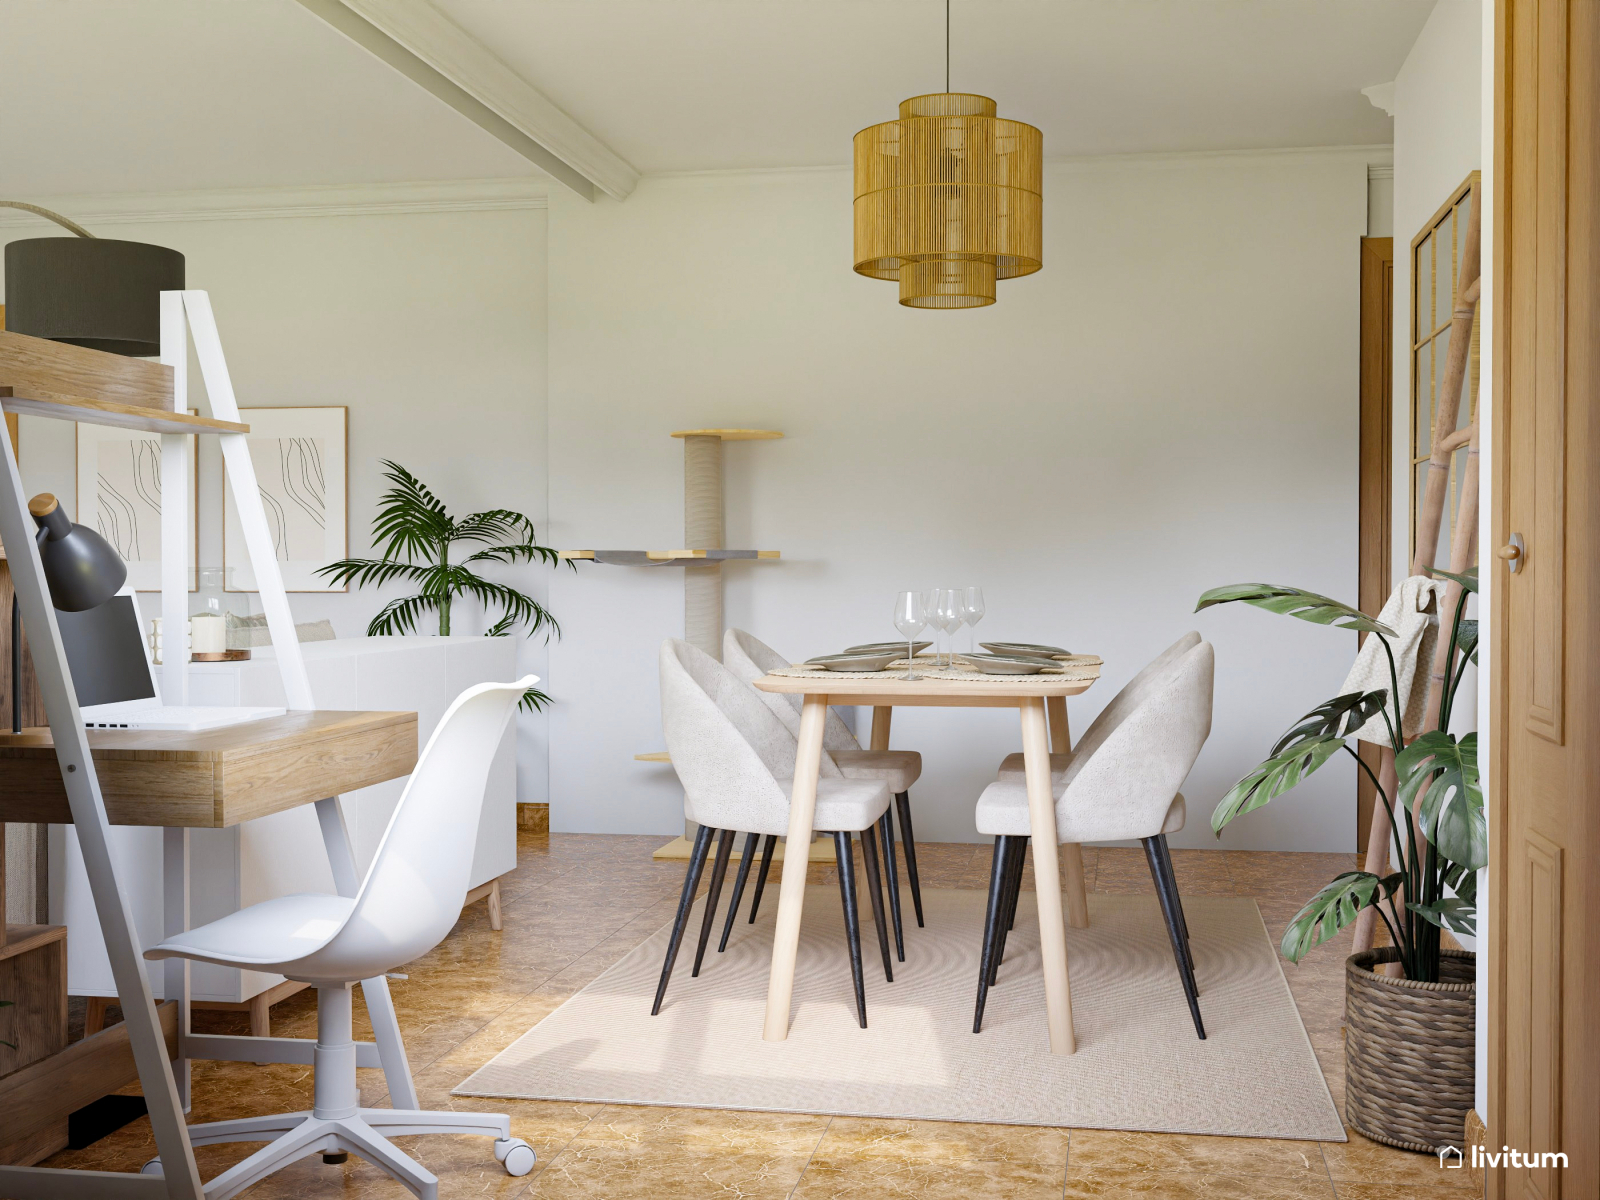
[1488,0,1600,1200]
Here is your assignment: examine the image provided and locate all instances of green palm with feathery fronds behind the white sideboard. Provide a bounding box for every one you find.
[317,459,562,709]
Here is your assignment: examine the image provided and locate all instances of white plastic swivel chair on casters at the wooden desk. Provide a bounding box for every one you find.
[144,675,538,1200]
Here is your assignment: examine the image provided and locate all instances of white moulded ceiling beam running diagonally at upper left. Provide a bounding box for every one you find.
[299,0,638,200]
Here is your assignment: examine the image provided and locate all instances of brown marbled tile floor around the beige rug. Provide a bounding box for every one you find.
[46,834,1474,1200]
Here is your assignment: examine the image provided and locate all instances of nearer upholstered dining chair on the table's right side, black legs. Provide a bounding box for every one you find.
[973,642,1216,1038]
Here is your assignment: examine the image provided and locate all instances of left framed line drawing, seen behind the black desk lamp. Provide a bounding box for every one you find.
[75,419,200,592]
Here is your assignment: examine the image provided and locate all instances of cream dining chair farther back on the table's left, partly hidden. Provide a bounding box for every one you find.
[722,629,922,962]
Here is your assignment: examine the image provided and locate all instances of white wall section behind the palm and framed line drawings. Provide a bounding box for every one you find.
[0,195,550,802]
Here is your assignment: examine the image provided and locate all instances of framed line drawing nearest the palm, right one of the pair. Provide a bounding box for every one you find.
[222,405,350,592]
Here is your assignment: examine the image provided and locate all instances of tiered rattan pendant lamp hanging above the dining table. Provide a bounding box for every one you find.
[854,0,1043,309]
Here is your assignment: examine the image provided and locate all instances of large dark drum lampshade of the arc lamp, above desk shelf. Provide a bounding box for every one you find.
[5,237,184,357]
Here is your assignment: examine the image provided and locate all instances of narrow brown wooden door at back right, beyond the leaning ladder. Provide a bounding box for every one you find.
[1355,237,1395,853]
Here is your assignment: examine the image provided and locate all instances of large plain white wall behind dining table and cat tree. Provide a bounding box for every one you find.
[550,150,1366,851]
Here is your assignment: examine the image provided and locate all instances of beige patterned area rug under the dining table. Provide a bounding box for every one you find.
[456,878,1344,1141]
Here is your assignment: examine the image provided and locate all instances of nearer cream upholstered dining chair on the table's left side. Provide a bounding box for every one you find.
[650,638,894,1029]
